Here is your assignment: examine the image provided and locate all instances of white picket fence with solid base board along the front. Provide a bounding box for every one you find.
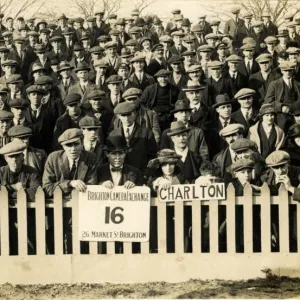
[0,184,300,284]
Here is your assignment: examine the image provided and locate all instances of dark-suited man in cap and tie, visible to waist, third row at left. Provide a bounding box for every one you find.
[25,85,56,153]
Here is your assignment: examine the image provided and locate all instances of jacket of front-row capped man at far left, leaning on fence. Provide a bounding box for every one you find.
[0,164,42,202]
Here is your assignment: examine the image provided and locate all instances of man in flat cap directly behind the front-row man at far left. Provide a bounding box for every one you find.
[8,125,47,176]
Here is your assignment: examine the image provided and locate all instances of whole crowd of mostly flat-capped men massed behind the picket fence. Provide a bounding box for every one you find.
[0,7,300,252]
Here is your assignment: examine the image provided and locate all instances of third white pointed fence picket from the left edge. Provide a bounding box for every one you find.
[35,187,46,255]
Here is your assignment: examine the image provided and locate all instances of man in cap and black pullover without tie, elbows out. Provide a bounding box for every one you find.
[140,70,179,131]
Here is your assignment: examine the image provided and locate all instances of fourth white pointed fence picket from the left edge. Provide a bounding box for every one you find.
[53,187,64,255]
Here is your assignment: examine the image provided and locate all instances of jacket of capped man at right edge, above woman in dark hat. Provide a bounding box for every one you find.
[265,77,300,112]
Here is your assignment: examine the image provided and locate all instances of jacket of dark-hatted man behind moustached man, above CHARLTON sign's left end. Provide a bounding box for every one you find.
[160,126,209,161]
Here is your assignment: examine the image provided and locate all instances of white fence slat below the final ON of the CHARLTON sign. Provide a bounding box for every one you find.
[209,200,219,253]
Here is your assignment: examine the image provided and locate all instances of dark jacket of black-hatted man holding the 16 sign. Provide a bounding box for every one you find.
[98,163,144,186]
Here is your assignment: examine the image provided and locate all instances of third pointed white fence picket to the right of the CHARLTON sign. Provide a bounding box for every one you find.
[260,182,271,253]
